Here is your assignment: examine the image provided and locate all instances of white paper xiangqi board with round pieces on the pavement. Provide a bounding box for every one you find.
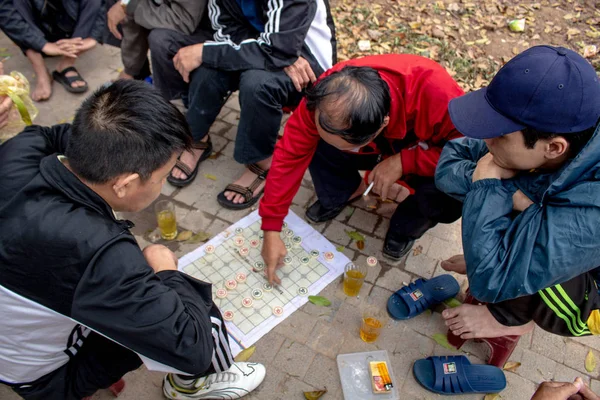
[179,211,350,355]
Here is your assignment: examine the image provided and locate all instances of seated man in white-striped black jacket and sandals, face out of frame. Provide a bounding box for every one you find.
[168,0,336,209]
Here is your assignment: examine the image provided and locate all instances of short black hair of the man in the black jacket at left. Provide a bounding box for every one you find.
[65,80,191,183]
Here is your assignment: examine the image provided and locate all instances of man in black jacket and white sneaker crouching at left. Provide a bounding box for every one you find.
[0,81,265,400]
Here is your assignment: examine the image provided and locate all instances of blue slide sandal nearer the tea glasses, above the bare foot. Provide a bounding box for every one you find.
[387,274,460,320]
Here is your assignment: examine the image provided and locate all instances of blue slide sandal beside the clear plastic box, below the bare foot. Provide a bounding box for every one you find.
[413,356,506,395]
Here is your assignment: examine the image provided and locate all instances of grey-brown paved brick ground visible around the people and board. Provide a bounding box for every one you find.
[0,36,600,400]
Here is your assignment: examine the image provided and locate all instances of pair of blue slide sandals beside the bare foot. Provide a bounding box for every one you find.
[387,275,506,395]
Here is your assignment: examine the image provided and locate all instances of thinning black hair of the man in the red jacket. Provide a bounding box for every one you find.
[306,66,391,144]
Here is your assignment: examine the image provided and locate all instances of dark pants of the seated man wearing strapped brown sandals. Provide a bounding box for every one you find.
[187,66,322,164]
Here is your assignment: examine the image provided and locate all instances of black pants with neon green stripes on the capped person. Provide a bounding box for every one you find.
[487,272,600,336]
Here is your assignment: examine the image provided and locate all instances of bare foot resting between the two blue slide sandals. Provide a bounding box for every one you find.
[442,304,534,339]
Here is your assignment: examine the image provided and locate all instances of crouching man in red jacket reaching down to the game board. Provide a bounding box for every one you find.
[260,55,463,283]
